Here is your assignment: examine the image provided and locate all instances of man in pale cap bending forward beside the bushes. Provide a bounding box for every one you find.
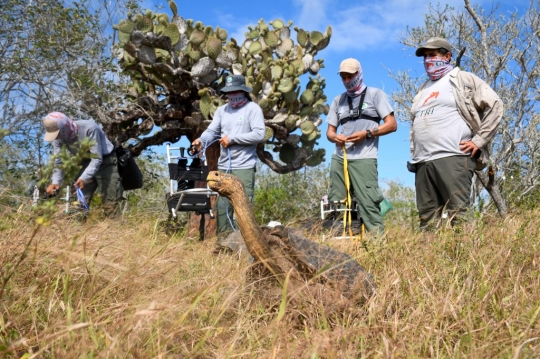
[43,112,123,216]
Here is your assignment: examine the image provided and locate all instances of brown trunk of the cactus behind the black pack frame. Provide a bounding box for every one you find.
[187,142,221,241]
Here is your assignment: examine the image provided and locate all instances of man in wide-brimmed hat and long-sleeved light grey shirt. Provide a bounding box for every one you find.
[192,75,265,232]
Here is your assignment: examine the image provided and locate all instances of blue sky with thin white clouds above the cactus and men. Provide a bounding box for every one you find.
[138,0,528,187]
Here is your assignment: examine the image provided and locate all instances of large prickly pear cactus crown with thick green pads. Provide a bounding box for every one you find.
[104,0,332,173]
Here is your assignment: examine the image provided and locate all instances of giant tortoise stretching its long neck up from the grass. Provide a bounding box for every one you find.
[207,171,375,301]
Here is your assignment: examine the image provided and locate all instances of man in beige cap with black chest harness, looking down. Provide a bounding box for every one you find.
[326,58,397,234]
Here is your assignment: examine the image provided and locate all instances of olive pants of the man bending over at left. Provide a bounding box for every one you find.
[77,151,124,216]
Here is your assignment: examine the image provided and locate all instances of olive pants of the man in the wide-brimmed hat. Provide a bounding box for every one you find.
[217,168,255,233]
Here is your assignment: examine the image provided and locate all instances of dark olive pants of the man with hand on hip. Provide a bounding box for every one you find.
[415,156,476,230]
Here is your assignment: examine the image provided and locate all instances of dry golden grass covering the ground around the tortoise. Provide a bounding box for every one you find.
[0,204,540,358]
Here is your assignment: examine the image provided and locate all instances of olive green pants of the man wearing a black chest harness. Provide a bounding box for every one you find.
[328,155,384,233]
